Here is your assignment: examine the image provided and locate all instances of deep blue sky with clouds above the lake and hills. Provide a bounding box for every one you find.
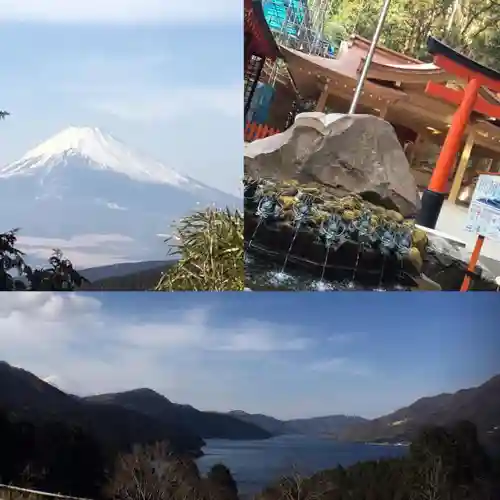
[0,292,500,418]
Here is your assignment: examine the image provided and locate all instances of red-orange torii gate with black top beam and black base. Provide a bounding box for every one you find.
[417,37,500,229]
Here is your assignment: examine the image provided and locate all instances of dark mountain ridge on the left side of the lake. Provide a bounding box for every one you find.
[0,362,271,454]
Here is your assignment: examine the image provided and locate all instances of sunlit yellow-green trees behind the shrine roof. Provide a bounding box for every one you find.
[327,0,500,69]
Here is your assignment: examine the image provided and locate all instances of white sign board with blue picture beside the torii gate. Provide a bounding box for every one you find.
[465,174,500,241]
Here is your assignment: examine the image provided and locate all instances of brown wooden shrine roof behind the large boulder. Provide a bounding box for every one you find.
[280,36,500,157]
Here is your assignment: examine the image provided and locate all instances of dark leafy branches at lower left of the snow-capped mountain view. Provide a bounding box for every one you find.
[0,229,87,291]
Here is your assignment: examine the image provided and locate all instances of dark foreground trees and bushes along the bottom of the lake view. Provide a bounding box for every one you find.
[0,420,500,500]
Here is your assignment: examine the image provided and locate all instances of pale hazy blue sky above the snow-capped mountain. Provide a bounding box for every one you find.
[0,0,243,193]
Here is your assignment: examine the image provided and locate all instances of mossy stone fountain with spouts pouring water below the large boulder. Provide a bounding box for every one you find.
[244,177,428,291]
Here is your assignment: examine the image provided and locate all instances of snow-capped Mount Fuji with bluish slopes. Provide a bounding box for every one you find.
[0,127,241,268]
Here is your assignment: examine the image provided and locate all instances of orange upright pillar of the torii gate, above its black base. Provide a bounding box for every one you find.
[428,78,481,193]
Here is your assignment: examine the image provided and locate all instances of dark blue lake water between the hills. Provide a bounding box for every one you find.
[197,436,407,495]
